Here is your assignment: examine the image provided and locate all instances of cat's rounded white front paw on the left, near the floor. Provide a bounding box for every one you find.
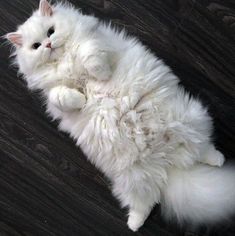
[48,86,86,111]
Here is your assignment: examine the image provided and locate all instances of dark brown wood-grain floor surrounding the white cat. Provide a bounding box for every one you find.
[0,0,235,236]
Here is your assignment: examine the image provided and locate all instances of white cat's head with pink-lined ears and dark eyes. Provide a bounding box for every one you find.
[6,0,76,75]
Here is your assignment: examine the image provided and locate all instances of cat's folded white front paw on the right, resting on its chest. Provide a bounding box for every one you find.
[80,40,112,80]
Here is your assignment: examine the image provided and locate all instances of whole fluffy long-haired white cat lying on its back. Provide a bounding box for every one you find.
[6,0,235,231]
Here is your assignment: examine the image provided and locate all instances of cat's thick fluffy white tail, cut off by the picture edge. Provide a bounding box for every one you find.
[162,162,235,225]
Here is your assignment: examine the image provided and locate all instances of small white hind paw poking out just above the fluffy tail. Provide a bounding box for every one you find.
[201,144,225,167]
